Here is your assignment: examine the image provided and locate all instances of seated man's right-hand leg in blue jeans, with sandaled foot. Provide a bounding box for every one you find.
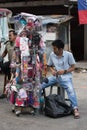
[59,79,79,118]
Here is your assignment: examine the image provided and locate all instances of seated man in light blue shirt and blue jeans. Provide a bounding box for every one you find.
[40,40,79,118]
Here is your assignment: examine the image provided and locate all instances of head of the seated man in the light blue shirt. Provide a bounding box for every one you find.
[52,39,64,56]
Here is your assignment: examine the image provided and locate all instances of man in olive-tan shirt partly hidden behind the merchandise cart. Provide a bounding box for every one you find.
[0,29,17,98]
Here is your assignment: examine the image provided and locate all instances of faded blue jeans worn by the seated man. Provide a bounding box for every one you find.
[40,76,78,109]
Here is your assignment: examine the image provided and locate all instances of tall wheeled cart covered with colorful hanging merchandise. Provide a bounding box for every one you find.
[6,13,46,116]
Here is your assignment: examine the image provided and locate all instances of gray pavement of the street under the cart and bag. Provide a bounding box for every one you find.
[0,63,87,130]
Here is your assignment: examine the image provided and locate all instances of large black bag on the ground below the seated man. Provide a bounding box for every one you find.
[44,94,72,118]
